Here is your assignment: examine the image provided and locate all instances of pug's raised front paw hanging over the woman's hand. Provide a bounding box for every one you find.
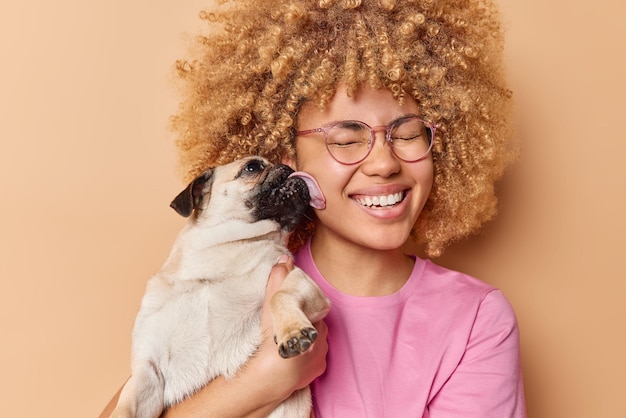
[270,268,330,358]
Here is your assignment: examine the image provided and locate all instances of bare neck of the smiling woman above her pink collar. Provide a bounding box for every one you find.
[311,231,414,296]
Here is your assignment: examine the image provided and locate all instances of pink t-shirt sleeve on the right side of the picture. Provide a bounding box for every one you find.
[428,290,526,418]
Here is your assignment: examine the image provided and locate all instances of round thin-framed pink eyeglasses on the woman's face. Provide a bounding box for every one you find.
[296,115,437,165]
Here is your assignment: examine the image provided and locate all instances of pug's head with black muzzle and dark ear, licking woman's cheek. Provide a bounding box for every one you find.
[170,157,310,230]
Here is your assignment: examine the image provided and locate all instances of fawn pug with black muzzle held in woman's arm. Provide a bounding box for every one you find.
[111,157,330,418]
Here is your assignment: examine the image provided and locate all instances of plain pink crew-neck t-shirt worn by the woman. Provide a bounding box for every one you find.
[295,245,526,418]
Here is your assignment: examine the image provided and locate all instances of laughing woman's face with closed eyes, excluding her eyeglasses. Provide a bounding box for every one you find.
[294,83,433,250]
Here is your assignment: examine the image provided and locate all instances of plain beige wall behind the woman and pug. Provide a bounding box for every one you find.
[0,0,626,418]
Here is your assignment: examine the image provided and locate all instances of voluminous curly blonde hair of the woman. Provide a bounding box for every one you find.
[172,0,514,256]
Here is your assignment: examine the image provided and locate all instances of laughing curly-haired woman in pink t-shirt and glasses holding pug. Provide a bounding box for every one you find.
[103,0,525,418]
